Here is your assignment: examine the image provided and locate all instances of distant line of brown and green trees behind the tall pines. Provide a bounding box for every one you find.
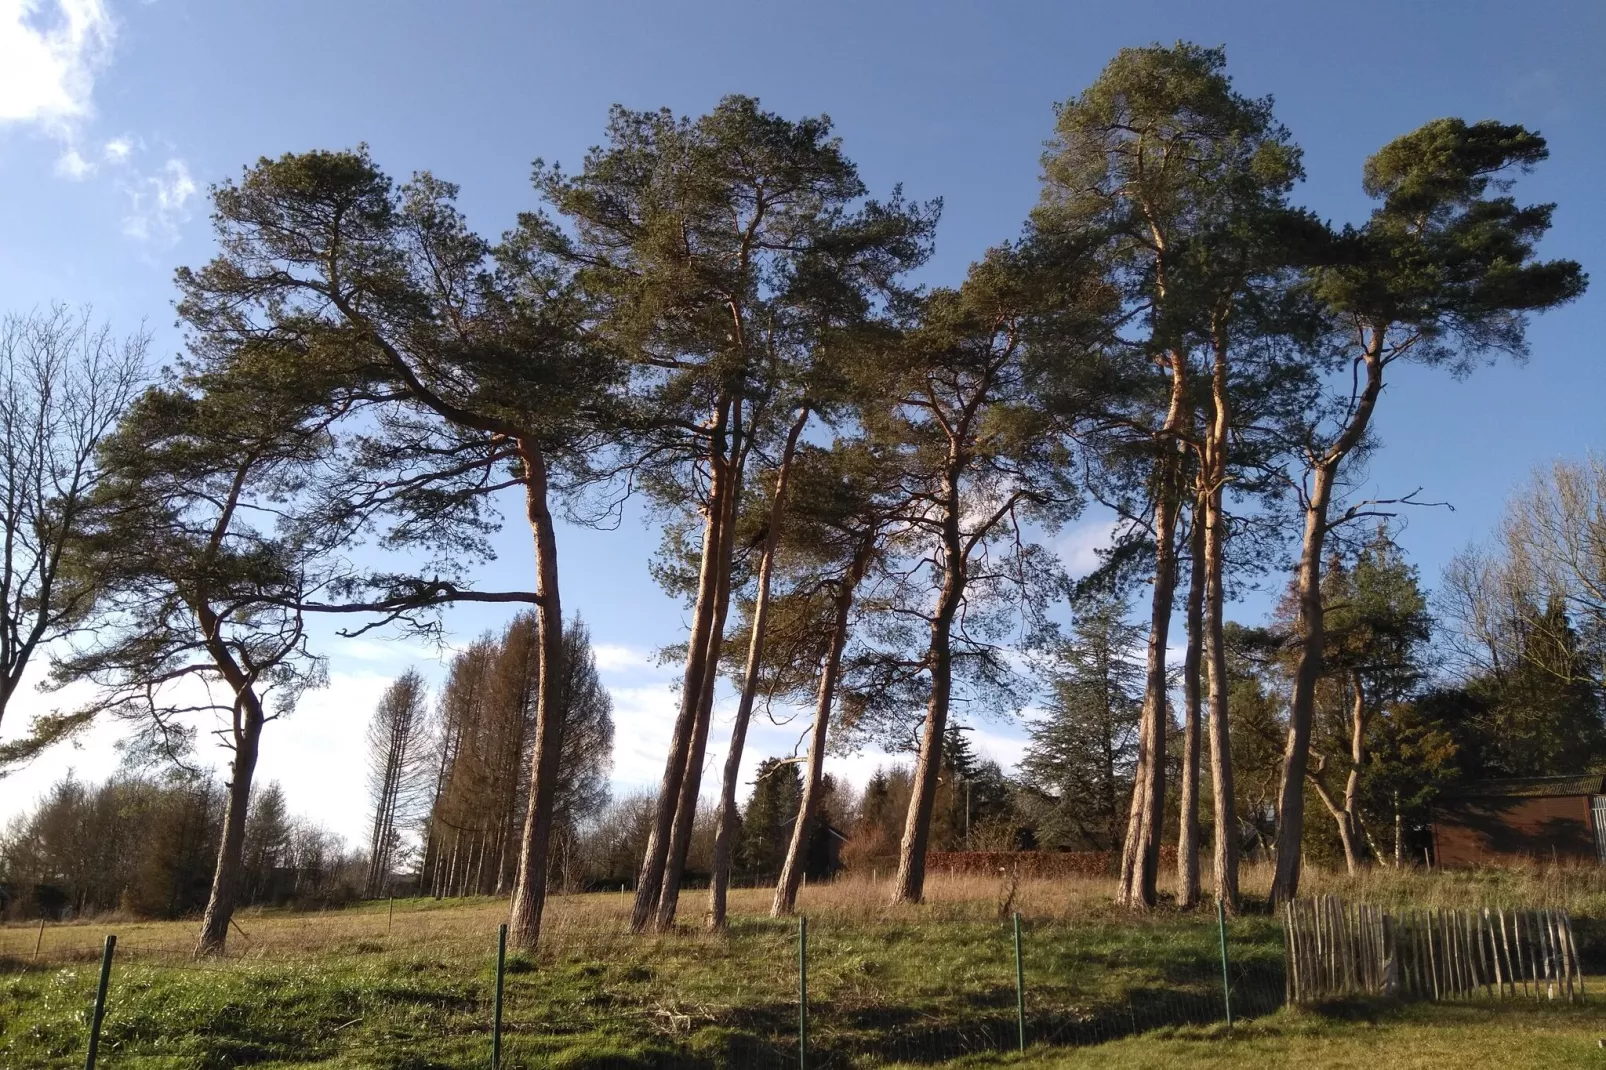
[9,488,1606,917]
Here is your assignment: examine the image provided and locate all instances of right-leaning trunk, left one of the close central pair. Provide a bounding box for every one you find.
[630,398,731,932]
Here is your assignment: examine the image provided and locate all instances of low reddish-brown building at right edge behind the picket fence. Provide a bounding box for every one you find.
[1433,773,1606,866]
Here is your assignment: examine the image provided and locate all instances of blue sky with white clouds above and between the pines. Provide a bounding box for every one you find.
[0,0,1606,834]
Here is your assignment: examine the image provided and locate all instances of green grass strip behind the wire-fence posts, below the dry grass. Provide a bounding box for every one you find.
[0,899,1280,1070]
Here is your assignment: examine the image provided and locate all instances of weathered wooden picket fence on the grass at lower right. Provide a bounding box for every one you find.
[1283,896,1584,1003]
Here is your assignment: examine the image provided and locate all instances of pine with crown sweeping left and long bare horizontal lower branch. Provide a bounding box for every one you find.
[169,148,612,948]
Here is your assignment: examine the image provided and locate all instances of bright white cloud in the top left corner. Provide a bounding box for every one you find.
[0,0,116,138]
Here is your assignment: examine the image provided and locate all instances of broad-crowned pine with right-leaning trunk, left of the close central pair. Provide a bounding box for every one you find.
[527,96,936,930]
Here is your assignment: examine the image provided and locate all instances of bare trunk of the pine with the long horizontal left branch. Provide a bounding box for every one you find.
[507,442,569,950]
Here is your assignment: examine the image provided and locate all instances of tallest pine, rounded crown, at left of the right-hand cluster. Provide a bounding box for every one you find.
[1033,43,1299,908]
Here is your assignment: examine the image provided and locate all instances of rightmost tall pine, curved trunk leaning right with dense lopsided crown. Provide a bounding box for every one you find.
[1272,119,1587,903]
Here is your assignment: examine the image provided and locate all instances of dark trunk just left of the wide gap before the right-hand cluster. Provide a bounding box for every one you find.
[893,471,967,903]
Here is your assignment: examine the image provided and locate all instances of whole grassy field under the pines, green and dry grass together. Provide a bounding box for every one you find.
[0,871,1606,1070]
